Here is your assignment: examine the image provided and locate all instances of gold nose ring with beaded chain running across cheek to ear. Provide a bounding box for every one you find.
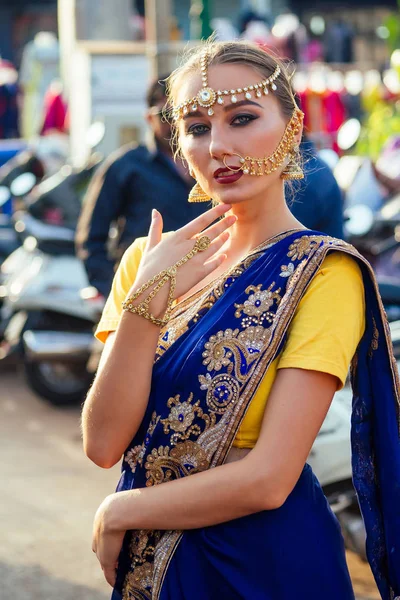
[222,107,304,175]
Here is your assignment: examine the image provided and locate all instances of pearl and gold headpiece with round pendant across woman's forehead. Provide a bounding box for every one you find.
[173,52,281,120]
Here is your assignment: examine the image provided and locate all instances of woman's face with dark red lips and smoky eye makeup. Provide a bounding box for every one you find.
[175,64,301,204]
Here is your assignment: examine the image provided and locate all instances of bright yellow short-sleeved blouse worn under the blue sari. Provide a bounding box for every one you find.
[95,238,365,448]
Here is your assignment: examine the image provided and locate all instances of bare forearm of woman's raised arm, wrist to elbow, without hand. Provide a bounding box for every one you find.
[82,313,163,468]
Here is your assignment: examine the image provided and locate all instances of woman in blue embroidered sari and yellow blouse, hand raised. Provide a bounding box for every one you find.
[83,42,400,600]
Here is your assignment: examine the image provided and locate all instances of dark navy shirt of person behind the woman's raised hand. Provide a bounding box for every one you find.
[76,146,205,296]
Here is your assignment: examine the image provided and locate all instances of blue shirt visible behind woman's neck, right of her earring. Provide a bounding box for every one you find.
[289,142,343,238]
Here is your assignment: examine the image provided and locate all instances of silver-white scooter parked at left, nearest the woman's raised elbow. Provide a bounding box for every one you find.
[0,215,97,405]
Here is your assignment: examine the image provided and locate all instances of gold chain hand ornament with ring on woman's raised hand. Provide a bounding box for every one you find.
[122,235,211,327]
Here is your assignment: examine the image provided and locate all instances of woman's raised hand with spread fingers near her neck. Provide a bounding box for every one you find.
[129,204,236,312]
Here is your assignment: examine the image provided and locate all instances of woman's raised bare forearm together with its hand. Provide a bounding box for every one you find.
[82,204,236,468]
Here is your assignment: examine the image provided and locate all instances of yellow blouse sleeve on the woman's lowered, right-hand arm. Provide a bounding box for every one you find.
[278,245,365,387]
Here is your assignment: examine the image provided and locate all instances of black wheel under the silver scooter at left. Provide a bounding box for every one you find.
[24,360,92,406]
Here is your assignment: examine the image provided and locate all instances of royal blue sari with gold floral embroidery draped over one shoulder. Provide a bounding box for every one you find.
[112,230,400,600]
